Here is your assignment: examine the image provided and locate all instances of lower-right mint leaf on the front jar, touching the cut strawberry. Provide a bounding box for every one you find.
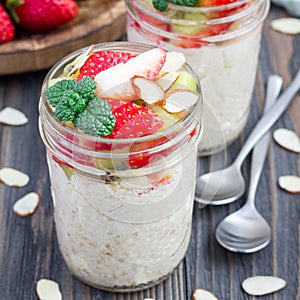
[73,97,116,136]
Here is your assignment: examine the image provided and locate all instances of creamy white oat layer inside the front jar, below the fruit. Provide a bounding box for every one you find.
[48,151,196,289]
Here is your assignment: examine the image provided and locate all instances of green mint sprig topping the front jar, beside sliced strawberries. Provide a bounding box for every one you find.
[45,76,116,136]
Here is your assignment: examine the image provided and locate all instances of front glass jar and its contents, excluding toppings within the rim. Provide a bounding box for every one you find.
[39,42,202,291]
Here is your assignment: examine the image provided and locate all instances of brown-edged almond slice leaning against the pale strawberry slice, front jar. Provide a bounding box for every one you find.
[132,76,164,105]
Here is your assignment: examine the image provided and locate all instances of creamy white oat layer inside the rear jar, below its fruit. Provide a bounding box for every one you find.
[127,18,261,154]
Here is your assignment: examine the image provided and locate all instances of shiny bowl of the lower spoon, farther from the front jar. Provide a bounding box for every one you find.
[215,206,271,253]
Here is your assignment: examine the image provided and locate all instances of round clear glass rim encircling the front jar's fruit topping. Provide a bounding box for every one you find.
[40,41,203,145]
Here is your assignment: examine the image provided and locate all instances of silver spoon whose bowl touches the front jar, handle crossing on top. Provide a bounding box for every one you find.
[195,69,300,205]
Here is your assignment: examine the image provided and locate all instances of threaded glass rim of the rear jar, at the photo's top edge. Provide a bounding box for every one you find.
[125,0,270,42]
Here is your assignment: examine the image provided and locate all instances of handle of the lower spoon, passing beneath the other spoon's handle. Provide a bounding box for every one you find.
[247,75,282,206]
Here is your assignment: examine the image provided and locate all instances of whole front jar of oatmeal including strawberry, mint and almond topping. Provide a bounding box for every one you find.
[40,43,202,291]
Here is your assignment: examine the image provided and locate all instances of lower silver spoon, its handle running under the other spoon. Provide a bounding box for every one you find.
[215,77,276,253]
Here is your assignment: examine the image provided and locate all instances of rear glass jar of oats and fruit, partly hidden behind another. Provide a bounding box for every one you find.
[126,0,270,155]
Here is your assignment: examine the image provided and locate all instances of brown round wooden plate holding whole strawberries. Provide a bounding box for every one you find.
[0,0,126,75]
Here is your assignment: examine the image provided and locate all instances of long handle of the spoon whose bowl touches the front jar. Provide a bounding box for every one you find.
[235,69,300,167]
